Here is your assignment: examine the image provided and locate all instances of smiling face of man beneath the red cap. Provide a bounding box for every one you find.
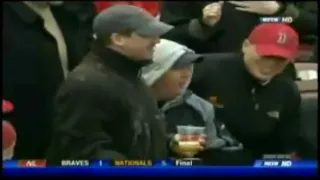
[242,42,288,81]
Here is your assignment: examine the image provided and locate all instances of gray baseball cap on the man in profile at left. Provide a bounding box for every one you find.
[93,4,173,39]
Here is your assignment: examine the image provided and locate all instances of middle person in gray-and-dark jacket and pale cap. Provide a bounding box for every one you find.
[142,39,246,163]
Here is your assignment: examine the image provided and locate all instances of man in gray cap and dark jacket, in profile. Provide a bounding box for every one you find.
[48,5,172,163]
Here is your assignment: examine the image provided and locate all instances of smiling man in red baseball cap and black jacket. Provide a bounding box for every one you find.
[191,23,310,158]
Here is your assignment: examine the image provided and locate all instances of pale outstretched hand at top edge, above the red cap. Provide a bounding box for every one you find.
[228,1,280,15]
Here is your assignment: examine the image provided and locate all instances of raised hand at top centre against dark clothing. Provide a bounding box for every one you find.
[202,1,223,26]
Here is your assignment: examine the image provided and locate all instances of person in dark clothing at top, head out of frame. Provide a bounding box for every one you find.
[160,1,317,53]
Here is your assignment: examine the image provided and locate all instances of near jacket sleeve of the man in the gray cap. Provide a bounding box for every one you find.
[54,77,125,159]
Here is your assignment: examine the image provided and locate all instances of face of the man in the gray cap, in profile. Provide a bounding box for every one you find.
[112,33,160,61]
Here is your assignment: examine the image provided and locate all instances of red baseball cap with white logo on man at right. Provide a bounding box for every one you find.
[248,23,299,61]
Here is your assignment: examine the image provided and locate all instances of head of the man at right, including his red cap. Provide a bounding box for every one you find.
[242,23,299,80]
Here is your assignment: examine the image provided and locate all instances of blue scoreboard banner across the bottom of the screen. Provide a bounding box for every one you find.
[3,159,317,177]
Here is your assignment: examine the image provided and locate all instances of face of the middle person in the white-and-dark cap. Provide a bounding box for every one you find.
[152,65,192,100]
